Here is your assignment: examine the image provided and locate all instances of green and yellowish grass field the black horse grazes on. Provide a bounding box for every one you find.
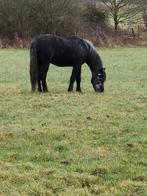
[0,48,147,196]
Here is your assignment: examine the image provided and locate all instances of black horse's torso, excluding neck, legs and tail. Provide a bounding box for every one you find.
[33,35,87,66]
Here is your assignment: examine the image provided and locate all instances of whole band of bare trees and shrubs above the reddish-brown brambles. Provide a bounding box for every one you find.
[0,0,147,39]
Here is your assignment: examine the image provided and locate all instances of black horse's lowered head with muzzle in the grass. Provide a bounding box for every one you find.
[91,68,106,93]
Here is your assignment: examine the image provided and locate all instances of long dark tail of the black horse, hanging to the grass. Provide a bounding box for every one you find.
[30,40,38,92]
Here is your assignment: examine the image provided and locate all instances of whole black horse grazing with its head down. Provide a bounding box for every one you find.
[30,35,106,92]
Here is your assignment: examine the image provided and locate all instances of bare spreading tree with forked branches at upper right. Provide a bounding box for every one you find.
[102,0,141,34]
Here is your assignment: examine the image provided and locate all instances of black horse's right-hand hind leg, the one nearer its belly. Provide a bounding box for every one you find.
[41,64,49,92]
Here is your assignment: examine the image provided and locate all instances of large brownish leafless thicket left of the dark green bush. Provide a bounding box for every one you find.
[0,0,79,39]
